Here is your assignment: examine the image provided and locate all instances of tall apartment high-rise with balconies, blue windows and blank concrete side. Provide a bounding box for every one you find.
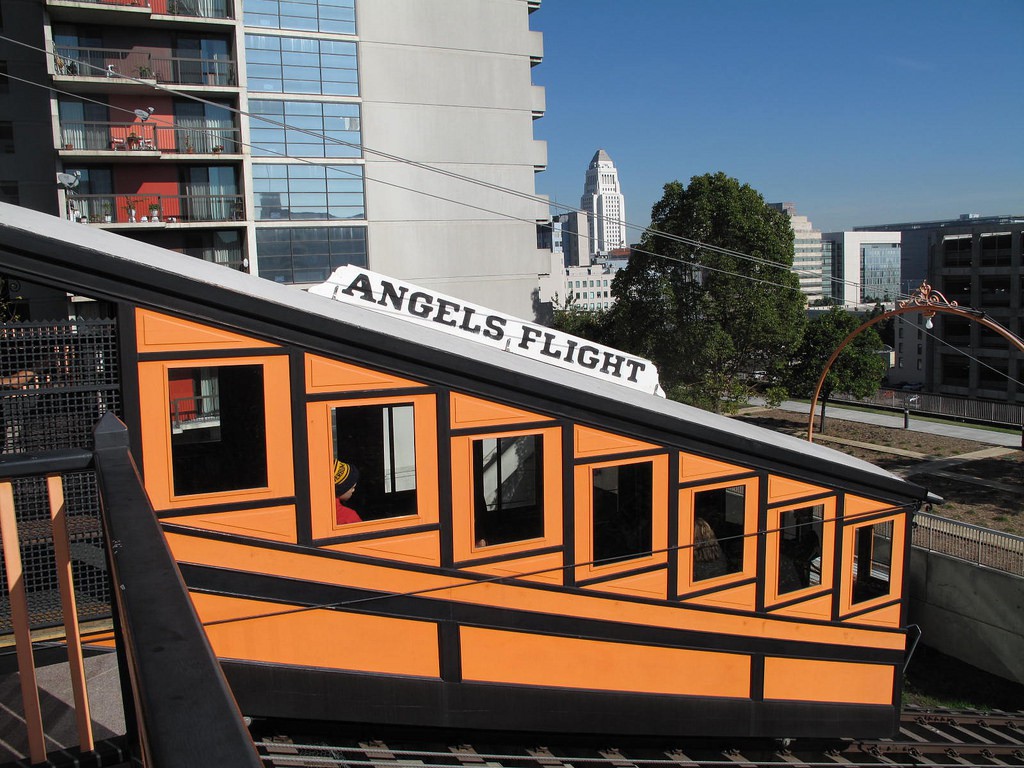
[0,0,548,317]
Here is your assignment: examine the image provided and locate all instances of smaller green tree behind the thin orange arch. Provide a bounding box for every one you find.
[787,307,886,432]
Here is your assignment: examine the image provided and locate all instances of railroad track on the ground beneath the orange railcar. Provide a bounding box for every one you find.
[254,710,1024,768]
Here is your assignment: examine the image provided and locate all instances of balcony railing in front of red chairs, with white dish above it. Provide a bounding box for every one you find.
[60,122,242,155]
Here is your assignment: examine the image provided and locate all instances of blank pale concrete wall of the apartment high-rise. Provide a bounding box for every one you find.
[356,0,549,318]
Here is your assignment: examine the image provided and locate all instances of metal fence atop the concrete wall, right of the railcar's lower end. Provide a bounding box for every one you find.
[913,512,1024,577]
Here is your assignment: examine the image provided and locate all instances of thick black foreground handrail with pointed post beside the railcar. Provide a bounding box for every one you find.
[94,413,261,768]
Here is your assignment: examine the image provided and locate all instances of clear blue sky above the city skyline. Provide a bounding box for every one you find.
[530,0,1024,234]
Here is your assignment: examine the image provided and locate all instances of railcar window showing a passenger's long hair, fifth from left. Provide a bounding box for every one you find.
[693,485,746,582]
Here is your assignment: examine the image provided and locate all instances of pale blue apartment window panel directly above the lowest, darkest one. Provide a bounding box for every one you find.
[253,164,366,221]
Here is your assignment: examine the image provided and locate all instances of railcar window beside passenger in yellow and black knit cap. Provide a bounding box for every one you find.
[331,403,417,523]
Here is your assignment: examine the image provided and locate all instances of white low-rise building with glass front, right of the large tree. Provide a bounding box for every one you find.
[821,231,900,306]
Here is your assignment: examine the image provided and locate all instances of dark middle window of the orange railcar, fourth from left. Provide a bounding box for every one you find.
[592,462,653,563]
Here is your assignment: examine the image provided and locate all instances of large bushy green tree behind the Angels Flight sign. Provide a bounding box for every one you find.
[608,173,805,411]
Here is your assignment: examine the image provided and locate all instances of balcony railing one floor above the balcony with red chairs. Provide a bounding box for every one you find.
[53,45,238,86]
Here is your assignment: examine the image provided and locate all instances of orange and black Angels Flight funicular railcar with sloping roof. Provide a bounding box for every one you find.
[0,206,927,736]
